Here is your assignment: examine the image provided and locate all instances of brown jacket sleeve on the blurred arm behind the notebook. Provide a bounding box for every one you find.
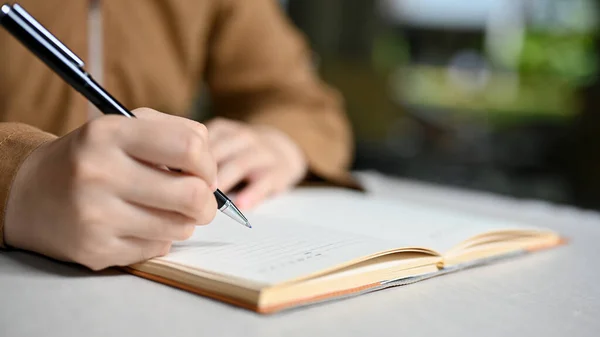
[206,0,353,183]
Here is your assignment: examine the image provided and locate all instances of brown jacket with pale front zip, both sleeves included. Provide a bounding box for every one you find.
[0,0,353,246]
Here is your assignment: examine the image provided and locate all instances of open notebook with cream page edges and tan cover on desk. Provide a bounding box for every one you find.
[126,188,562,313]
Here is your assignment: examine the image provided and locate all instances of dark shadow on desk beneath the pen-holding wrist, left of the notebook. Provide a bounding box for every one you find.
[0,251,123,278]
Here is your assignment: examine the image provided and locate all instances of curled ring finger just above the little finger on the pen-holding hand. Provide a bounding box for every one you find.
[113,200,196,241]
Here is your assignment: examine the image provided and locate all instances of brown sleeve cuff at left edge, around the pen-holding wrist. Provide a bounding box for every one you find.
[0,123,56,248]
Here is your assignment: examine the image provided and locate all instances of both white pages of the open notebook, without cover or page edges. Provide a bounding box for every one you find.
[156,188,532,284]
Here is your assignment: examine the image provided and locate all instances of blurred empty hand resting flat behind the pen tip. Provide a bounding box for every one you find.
[206,118,307,209]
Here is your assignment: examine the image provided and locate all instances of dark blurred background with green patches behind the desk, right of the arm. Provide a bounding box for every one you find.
[282,0,600,209]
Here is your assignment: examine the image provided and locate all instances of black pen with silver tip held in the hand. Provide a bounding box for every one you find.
[0,4,252,228]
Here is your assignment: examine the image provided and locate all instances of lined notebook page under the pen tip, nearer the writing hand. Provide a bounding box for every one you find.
[160,214,395,284]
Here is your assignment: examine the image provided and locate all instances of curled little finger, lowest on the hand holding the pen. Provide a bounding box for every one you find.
[115,238,171,266]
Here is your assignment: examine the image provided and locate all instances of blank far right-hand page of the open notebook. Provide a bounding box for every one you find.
[249,188,537,253]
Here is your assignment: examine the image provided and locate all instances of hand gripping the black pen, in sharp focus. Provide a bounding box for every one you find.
[4,109,217,270]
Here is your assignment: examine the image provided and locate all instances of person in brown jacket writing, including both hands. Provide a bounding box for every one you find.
[0,0,354,270]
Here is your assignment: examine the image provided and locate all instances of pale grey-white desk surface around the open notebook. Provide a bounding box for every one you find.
[0,173,600,337]
